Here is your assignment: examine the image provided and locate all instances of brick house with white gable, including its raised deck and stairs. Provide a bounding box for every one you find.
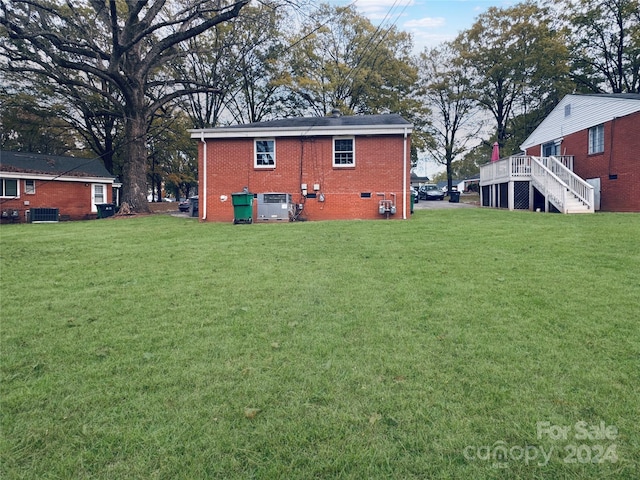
[480,94,640,213]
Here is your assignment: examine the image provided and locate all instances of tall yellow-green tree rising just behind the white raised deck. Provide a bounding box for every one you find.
[455,1,571,153]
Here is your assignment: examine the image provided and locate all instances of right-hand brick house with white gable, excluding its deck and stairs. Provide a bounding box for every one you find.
[521,94,640,212]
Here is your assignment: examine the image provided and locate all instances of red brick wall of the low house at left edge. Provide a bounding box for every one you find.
[0,178,112,222]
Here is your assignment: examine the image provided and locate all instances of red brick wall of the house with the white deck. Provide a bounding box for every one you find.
[528,112,640,212]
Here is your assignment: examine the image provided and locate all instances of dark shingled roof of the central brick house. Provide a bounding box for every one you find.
[221,113,411,129]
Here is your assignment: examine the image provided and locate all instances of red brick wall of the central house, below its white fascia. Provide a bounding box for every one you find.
[198,135,411,222]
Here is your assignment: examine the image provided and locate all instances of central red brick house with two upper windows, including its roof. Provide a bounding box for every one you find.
[191,111,412,222]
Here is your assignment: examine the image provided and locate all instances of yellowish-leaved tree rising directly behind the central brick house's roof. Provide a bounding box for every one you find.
[283,4,417,115]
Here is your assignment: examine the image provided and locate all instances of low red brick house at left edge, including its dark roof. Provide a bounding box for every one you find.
[0,151,115,223]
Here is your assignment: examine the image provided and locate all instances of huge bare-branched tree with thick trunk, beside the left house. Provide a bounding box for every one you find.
[0,0,250,211]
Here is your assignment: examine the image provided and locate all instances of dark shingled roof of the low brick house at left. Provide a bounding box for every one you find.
[0,150,113,178]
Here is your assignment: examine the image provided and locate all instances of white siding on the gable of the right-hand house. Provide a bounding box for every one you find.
[520,95,640,150]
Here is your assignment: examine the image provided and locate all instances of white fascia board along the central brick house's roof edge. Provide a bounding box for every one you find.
[189,125,413,139]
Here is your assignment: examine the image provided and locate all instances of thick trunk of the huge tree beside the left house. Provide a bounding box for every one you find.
[122,111,150,213]
